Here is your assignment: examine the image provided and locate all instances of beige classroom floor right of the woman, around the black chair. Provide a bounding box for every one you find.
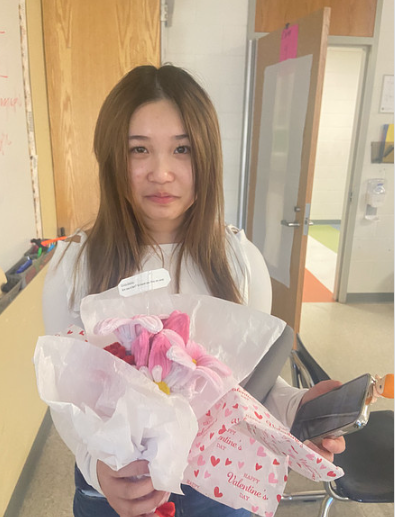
[275,302,394,517]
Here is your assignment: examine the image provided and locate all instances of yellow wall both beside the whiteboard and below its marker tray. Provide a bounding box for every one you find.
[0,0,57,516]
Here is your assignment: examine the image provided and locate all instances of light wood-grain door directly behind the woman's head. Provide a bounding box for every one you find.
[42,0,160,234]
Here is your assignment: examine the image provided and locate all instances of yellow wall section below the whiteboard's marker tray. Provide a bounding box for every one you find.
[0,268,47,515]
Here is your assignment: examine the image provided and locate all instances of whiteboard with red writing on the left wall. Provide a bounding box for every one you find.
[0,0,37,271]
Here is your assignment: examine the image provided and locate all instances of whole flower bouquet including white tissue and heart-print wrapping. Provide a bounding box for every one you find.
[34,282,343,517]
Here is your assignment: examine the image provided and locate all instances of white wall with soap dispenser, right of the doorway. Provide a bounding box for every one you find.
[347,0,394,293]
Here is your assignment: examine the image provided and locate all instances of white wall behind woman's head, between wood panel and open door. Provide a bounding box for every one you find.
[162,0,248,224]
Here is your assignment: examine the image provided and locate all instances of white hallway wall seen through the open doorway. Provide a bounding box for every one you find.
[311,47,364,221]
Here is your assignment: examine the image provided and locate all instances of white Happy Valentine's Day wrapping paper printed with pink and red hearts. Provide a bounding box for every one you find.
[183,387,342,517]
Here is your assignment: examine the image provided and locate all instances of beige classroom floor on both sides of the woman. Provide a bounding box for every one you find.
[13,303,394,517]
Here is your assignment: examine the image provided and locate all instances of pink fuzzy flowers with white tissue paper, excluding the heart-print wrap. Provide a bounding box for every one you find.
[34,288,285,493]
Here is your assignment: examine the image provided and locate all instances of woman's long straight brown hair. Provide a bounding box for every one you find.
[78,65,242,302]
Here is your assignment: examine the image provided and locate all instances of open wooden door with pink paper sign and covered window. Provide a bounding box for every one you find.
[247,8,330,332]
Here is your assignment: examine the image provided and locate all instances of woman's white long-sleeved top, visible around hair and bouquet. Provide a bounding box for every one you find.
[43,227,305,492]
